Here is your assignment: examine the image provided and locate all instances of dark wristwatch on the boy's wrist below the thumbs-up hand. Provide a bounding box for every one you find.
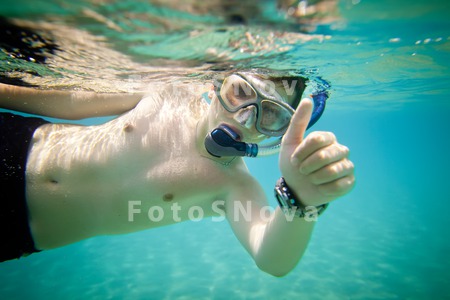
[275,177,328,221]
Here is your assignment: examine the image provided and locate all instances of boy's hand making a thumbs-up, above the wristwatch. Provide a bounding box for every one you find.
[279,99,355,206]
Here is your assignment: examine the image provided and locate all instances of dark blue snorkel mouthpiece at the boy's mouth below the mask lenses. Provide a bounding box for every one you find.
[205,125,258,157]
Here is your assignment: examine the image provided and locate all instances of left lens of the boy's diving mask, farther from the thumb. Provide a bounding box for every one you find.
[220,75,258,110]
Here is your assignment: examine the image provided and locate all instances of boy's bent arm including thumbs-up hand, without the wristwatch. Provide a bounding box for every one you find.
[225,99,355,276]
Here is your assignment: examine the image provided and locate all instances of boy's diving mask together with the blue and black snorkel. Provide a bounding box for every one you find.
[204,73,328,157]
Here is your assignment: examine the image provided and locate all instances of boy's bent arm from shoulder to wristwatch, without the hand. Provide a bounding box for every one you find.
[225,180,314,276]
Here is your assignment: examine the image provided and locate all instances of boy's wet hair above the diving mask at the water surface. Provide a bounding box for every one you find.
[214,69,307,110]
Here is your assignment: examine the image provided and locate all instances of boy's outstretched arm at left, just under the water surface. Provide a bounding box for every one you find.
[0,83,143,120]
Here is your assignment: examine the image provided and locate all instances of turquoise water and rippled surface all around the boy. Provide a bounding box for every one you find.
[0,0,450,300]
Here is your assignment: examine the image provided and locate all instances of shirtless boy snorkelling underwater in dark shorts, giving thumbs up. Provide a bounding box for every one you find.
[0,73,354,276]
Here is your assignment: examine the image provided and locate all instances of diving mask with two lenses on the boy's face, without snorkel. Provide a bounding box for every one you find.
[216,74,295,137]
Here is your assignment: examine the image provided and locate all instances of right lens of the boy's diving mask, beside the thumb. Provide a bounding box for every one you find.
[259,100,292,136]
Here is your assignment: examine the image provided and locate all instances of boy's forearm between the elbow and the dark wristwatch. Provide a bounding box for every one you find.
[254,208,315,276]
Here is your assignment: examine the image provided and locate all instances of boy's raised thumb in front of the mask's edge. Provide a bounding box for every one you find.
[283,98,314,145]
